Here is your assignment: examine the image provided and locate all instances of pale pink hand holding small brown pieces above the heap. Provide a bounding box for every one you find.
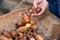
[32,0,48,16]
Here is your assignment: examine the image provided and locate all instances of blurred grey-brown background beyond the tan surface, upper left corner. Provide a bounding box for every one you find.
[0,0,33,16]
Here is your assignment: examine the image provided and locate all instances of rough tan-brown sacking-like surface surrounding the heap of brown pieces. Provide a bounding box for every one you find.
[0,0,60,40]
